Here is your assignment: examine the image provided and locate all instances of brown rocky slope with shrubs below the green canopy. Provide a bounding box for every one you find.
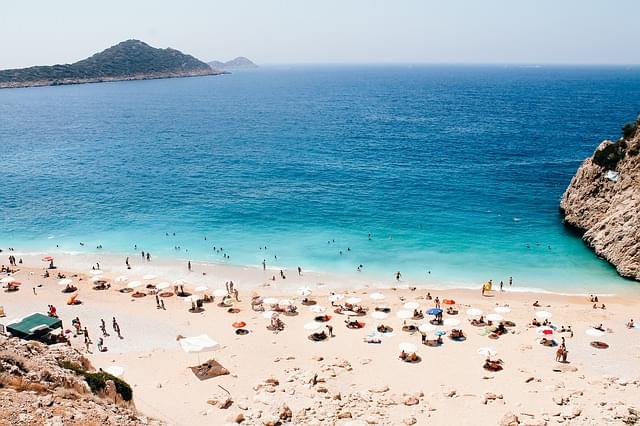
[0,336,161,426]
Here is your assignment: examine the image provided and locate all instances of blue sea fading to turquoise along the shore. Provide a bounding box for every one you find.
[0,66,640,291]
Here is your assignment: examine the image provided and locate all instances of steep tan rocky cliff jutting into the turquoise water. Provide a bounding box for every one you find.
[560,117,640,281]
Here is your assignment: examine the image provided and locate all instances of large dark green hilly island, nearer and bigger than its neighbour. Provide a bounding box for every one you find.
[0,40,224,88]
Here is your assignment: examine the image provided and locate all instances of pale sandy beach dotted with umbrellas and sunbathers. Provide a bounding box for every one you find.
[0,254,640,425]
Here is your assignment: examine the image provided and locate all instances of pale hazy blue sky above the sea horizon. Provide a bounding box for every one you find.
[0,0,640,69]
